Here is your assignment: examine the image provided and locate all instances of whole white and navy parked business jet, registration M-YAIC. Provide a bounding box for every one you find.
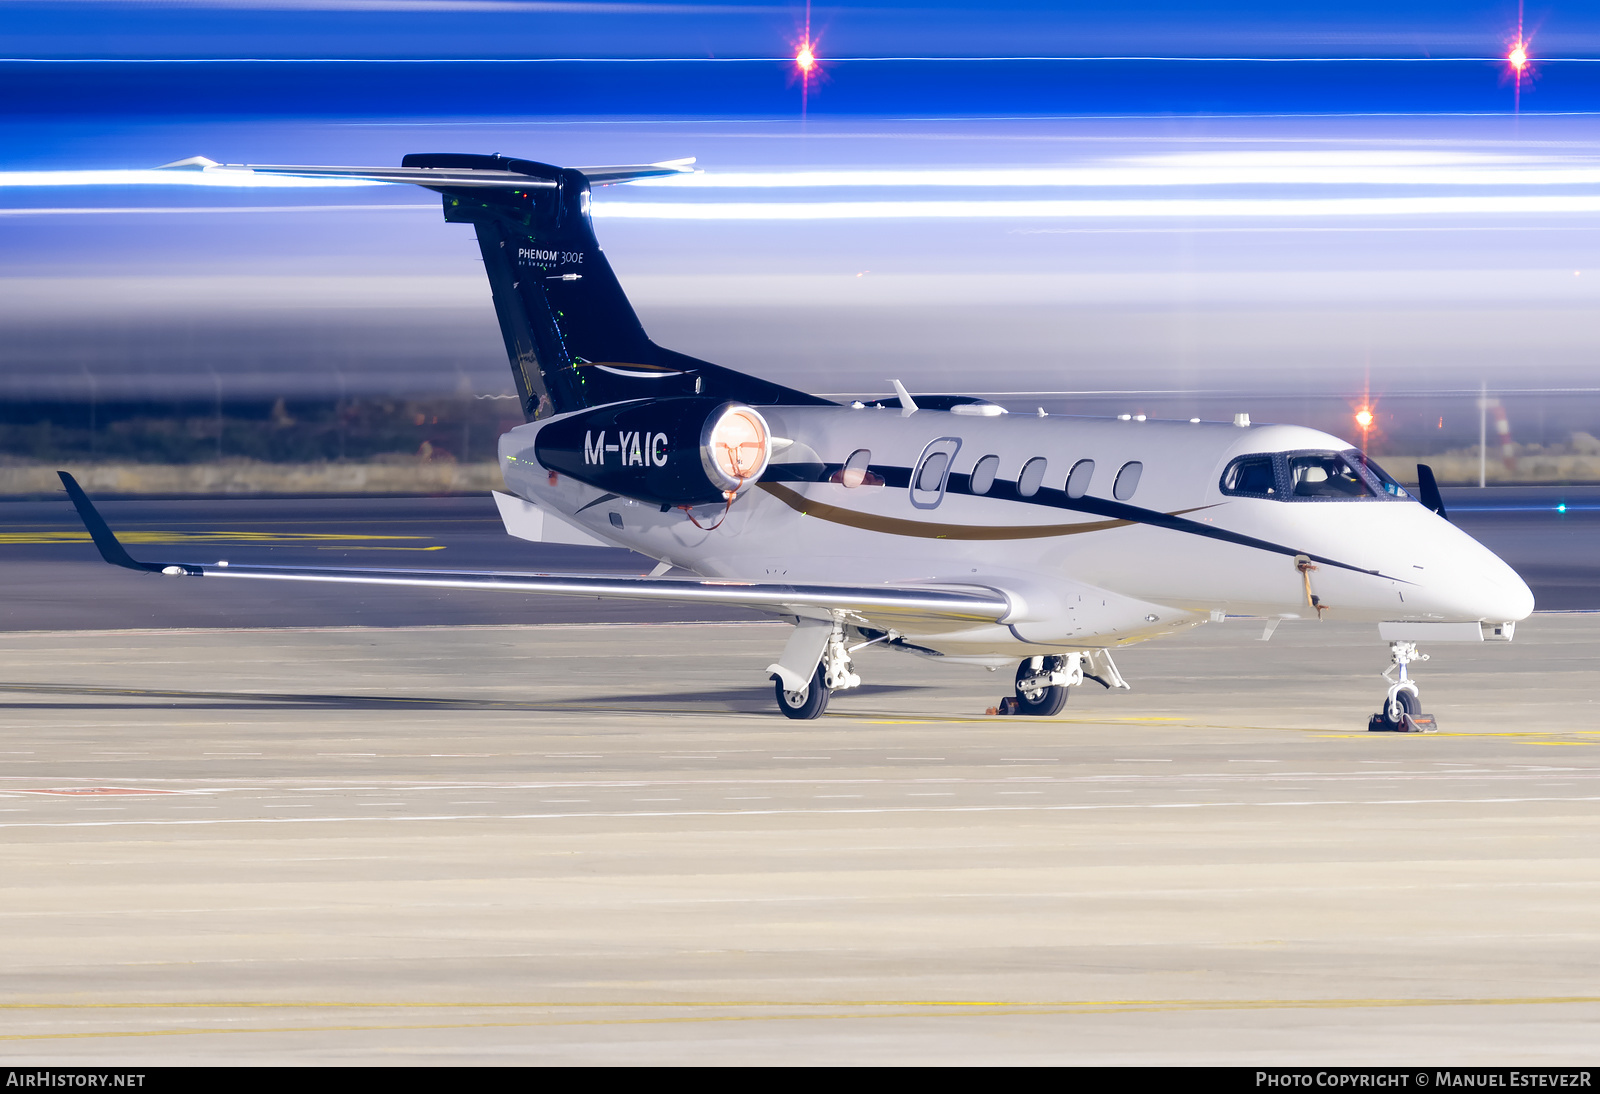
[61,155,1533,731]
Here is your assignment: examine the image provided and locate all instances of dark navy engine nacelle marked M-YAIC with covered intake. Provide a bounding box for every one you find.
[533,397,773,505]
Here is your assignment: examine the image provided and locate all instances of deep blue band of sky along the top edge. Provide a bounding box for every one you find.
[0,0,1600,117]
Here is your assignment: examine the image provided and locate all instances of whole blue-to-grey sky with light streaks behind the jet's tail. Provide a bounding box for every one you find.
[0,0,1600,445]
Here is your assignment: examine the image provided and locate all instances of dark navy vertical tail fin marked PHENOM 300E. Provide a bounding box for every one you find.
[403,155,827,421]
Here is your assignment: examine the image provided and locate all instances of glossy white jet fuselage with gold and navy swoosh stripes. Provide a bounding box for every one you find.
[501,406,1533,661]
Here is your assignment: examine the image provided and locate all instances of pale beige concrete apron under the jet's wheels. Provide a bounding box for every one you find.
[0,614,1600,1065]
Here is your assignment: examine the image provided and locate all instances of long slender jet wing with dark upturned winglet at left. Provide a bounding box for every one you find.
[59,472,1011,624]
